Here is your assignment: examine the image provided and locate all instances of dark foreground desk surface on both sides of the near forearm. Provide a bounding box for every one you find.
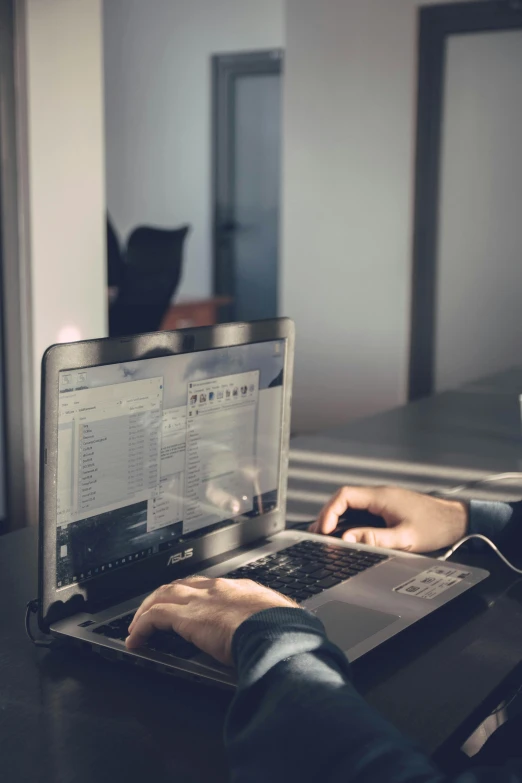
[0,528,522,783]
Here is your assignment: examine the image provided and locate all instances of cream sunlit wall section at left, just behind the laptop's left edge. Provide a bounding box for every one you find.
[23,0,107,422]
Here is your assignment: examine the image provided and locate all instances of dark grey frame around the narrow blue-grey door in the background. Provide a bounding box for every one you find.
[211,49,283,321]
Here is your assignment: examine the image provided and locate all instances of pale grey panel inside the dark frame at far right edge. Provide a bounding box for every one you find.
[436,30,522,391]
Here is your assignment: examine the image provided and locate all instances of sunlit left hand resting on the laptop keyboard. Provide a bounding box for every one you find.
[125,576,298,666]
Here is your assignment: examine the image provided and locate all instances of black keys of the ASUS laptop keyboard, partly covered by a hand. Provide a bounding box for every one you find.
[87,541,388,660]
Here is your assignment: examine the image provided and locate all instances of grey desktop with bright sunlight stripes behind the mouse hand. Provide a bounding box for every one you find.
[288,382,522,522]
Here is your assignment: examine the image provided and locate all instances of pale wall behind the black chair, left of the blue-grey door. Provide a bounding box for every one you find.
[104,0,284,298]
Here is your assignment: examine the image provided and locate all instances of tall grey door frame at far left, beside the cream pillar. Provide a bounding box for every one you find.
[0,0,37,532]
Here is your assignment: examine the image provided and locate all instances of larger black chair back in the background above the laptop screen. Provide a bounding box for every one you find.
[109,226,190,337]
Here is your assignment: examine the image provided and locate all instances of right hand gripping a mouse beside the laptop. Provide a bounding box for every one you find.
[309,487,468,552]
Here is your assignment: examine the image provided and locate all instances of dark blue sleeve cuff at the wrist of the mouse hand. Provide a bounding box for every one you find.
[469,500,522,555]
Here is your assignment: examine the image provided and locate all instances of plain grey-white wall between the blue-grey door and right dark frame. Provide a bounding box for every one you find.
[281,0,478,431]
